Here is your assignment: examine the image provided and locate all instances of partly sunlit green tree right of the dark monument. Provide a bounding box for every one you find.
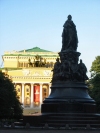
[89,56,100,112]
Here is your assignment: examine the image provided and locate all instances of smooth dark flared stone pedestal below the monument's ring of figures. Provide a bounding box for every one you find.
[41,82,96,113]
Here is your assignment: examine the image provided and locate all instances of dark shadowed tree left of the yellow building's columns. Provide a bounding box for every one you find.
[0,71,23,119]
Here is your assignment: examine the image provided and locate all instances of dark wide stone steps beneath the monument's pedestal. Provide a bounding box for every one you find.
[41,113,100,128]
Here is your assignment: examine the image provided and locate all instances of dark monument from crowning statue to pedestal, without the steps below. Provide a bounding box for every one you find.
[41,15,96,113]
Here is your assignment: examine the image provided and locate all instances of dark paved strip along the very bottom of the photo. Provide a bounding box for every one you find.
[0,129,100,133]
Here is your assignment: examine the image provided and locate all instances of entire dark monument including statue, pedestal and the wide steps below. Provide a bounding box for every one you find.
[24,15,100,129]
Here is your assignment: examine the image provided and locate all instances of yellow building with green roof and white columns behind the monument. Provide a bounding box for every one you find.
[2,47,58,114]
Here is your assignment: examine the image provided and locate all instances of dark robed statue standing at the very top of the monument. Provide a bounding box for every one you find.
[61,15,78,51]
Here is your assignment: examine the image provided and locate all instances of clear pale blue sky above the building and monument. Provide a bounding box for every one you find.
[0,0,100,76]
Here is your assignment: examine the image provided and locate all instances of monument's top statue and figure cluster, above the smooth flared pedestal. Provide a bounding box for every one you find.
[51,15,88,83]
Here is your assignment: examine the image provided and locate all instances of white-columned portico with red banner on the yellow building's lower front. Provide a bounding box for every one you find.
[15,82,51,114]
